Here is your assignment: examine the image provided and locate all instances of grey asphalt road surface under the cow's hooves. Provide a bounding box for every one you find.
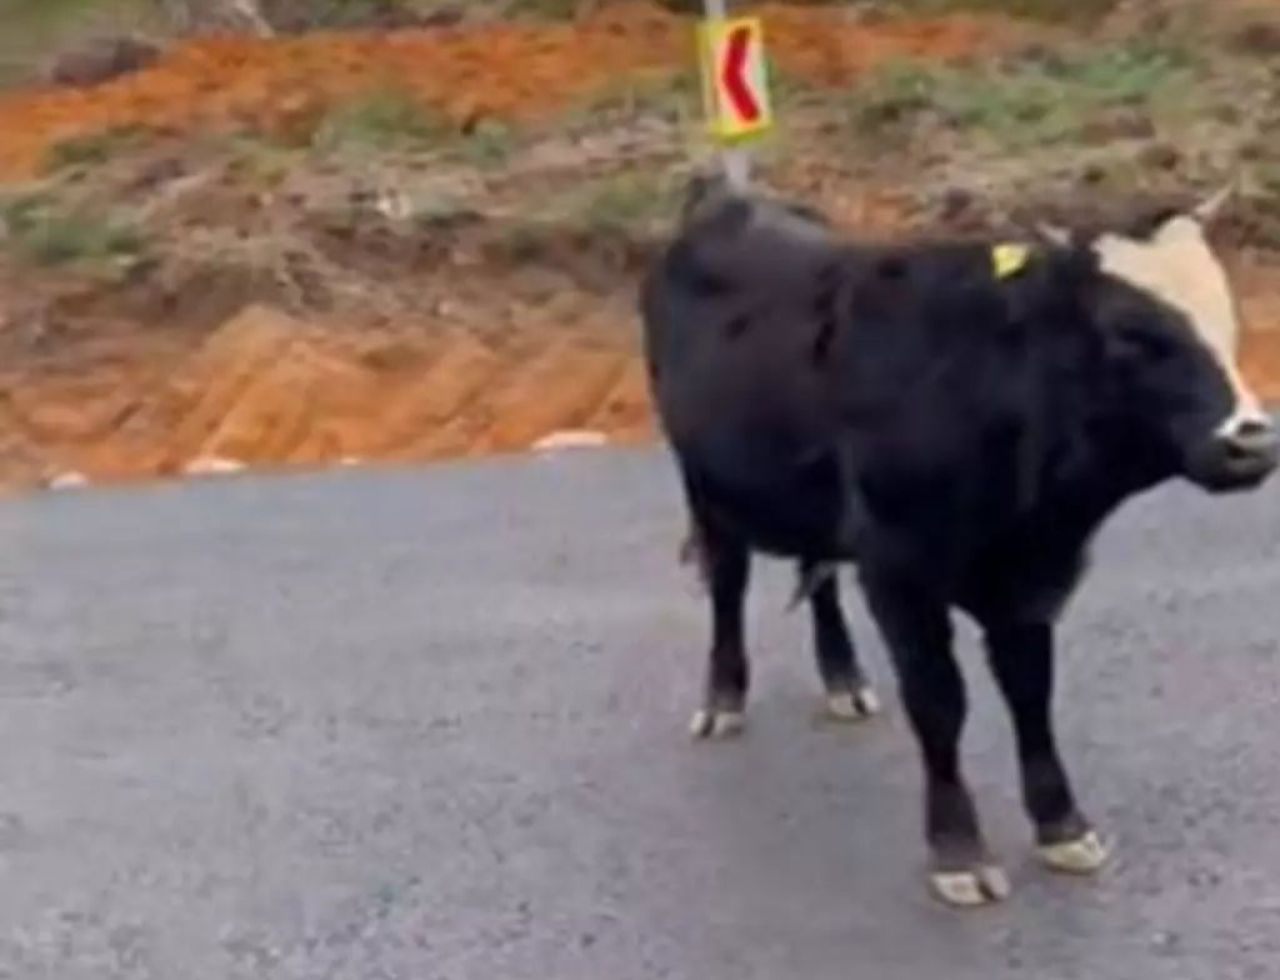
[0,453,1280,980]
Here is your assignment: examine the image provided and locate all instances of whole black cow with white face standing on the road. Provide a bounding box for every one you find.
[641,176,1277,905]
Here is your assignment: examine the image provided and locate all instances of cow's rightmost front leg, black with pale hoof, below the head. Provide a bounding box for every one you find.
[986,623,1108,874]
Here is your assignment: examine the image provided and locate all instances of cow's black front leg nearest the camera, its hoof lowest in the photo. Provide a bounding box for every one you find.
[864,574,1010,906]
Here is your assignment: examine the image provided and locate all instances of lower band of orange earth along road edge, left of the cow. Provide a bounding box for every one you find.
[6,306,649,482]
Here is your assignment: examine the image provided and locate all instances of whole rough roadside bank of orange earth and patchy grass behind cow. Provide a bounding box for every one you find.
[0,0,1280,490]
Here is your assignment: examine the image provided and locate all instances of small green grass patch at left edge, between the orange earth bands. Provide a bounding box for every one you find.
[0,193,143,269]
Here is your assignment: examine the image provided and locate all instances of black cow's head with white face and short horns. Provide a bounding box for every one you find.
[1046,188,1280,493]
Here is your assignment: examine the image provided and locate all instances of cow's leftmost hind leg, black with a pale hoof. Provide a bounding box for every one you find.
[690,527,751,738]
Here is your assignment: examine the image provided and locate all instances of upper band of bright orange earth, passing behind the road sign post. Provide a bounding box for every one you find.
[0,0,1027,178]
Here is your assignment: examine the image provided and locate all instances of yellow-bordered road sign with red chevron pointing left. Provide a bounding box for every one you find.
[699,17,773,143]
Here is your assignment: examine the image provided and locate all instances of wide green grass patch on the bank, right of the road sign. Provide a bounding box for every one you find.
[852,45,1193,147]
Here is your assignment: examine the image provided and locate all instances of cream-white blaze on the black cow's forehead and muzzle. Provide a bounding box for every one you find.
[1094,215,1266,432]
